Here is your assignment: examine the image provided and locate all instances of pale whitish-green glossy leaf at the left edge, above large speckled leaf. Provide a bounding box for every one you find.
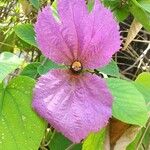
[0,52,23,83]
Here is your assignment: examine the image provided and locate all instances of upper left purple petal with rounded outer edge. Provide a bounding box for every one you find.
[35,6,72,64]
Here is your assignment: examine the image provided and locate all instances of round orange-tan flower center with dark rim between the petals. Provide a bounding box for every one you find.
[70,60,83,74]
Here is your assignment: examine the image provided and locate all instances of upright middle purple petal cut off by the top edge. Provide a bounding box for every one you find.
[58,0,88,60]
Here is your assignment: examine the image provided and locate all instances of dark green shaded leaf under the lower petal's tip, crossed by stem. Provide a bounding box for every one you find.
[49,132,82,150]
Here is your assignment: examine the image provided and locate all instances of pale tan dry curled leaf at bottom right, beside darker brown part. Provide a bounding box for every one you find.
[114,126,141,150]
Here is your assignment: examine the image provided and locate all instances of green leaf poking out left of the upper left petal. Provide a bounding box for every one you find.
[14,24,37,47]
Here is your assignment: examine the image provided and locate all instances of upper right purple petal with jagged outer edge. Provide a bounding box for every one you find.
[80,0,121,69]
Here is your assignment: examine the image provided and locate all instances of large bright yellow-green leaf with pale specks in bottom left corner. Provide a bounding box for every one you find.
[0,76,45,150]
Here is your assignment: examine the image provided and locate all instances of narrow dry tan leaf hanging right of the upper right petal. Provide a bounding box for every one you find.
[122,19,142,50]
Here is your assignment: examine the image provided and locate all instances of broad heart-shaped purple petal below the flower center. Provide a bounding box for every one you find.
[32,70,112,143]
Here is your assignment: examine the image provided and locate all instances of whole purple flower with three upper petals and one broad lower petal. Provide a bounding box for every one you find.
[32,0,121,143]
